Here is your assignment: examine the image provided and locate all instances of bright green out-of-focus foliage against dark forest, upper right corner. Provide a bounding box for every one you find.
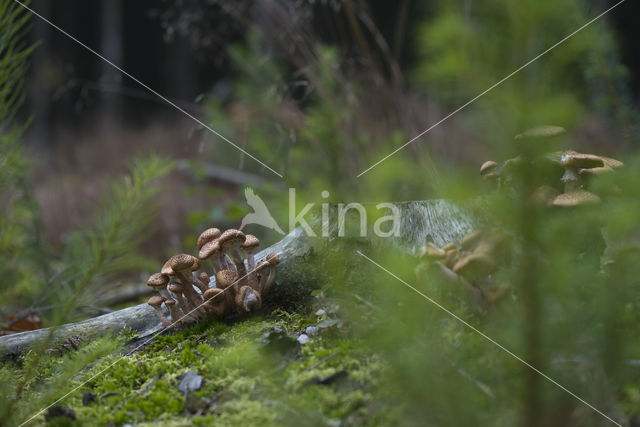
[414,0,638,154]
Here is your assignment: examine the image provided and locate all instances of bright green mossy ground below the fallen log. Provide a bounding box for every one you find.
[13,308,394,426]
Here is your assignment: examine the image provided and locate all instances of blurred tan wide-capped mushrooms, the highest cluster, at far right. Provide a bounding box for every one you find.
[480,126,623,208]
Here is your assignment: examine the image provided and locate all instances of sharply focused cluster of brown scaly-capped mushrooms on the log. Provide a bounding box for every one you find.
[147,228,280,326]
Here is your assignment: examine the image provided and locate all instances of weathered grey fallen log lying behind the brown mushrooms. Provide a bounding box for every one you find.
[0,199,488,357]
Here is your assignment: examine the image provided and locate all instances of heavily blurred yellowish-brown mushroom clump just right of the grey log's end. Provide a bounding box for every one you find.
[418,228,511,305]
